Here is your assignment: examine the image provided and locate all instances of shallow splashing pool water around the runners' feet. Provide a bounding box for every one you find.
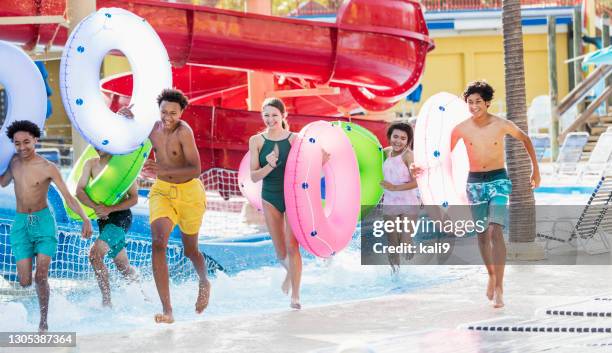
[0,241,474,334]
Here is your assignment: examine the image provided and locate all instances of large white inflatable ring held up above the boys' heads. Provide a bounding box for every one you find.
[60,8,172,154]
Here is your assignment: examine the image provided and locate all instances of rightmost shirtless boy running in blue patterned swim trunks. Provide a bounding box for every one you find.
[413,81,540,308]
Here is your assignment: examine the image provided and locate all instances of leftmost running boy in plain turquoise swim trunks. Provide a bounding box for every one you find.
[0,120,92,332]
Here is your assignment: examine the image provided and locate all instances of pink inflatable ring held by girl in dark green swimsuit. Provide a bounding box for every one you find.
[285,121,361,257]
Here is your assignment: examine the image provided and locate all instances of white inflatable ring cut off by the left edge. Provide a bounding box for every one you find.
[0,40,47,174]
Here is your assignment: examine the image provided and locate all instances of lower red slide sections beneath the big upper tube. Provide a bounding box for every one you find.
[102,65,394,170]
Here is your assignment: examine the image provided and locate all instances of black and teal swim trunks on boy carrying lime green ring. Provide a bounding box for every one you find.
[98,210,132,259]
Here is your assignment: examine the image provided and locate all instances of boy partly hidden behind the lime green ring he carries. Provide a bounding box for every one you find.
[76,149,138,307]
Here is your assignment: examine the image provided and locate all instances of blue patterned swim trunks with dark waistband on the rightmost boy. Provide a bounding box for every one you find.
[466,169,512,227]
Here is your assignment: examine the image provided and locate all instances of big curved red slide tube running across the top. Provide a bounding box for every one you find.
[0,0,434,111]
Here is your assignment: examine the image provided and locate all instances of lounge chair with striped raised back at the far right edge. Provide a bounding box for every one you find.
[537,176,612,254]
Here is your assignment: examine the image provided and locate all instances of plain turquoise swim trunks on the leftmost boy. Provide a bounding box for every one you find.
[9,208,57,261]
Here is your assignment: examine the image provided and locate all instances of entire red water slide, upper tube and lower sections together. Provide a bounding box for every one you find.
[0,0,433,174]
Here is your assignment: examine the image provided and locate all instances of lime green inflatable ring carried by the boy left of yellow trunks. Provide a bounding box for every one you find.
[64,139,152,220]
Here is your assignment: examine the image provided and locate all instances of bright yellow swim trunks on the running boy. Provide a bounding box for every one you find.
[149,179,206,234]
